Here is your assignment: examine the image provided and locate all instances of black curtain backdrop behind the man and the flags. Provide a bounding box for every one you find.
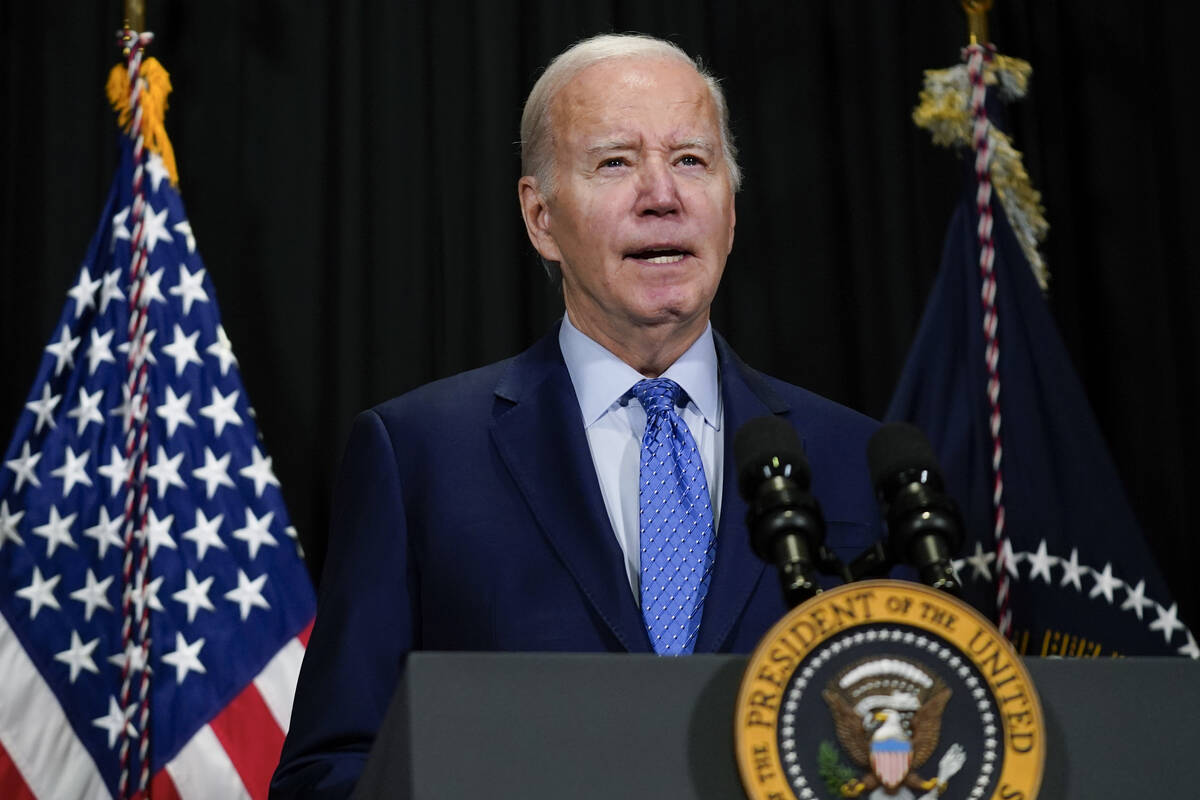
[0,0,1200,626]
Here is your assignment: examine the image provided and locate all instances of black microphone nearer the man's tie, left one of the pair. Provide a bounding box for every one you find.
[733,416,824,608]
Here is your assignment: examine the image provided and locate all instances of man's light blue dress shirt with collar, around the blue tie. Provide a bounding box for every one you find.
[558,314,725,599]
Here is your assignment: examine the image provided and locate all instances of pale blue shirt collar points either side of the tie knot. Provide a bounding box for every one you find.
[558,313,721,431]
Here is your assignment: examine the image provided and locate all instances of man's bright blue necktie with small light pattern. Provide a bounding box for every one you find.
[632,378,716,655]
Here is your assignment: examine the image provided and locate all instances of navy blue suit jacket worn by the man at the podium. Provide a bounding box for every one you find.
[272,326,880,796]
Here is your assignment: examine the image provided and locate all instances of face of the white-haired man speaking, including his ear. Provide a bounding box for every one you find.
[527,59,734,357]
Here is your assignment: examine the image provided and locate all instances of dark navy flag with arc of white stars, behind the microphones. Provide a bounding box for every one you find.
[886,174,1200,658]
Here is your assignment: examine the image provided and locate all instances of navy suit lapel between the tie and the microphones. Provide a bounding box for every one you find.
[696,335,788,652]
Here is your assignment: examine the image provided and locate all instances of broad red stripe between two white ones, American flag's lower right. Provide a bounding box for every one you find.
[209,682,283,800]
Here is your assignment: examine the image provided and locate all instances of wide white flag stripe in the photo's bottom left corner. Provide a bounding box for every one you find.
[0,614,112,798]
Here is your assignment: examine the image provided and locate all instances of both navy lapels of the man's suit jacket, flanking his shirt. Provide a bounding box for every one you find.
[492,324,788,652]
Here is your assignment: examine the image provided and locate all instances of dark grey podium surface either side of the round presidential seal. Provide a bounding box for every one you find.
[355,652,1200,800]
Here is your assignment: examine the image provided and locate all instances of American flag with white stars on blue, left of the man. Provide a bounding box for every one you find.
[0,45,316,798]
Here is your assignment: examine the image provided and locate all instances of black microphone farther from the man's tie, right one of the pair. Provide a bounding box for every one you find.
[866,422,962,595]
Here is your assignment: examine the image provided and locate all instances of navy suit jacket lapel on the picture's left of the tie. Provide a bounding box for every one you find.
[492,326,650,652]
